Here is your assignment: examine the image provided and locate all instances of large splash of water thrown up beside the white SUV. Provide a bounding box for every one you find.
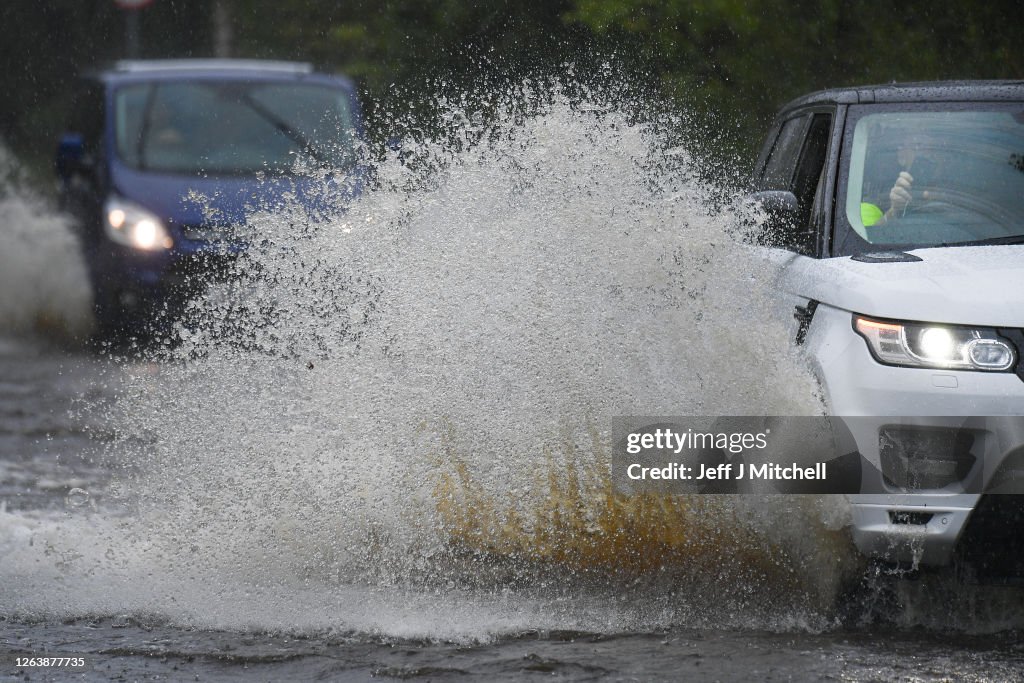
[2,90,876,638]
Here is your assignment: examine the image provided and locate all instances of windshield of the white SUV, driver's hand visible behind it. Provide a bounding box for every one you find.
[836,104,1024,255]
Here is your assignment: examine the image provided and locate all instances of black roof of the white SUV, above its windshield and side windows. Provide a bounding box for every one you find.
[780,81,1024,115]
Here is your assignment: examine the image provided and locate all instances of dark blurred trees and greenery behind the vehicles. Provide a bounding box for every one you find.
[0,0,1024,183]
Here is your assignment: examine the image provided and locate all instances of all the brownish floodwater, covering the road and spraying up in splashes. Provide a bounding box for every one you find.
[0,92,1024,681]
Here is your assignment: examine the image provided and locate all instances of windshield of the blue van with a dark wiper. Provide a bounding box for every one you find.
[115,81,355,175]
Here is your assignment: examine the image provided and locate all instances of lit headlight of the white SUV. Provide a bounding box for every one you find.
[853,315,1017,373]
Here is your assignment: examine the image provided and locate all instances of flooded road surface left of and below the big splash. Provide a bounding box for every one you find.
[8,278,1024,681]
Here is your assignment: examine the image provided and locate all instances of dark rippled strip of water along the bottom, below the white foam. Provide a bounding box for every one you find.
[8,620,1024,682]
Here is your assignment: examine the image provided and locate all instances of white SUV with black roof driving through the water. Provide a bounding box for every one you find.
[755,82,1024,578]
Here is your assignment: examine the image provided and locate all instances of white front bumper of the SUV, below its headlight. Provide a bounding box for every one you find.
[807,305,1024,566]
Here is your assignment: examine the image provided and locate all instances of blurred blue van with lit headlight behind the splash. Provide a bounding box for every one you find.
[56,59,365,336]
